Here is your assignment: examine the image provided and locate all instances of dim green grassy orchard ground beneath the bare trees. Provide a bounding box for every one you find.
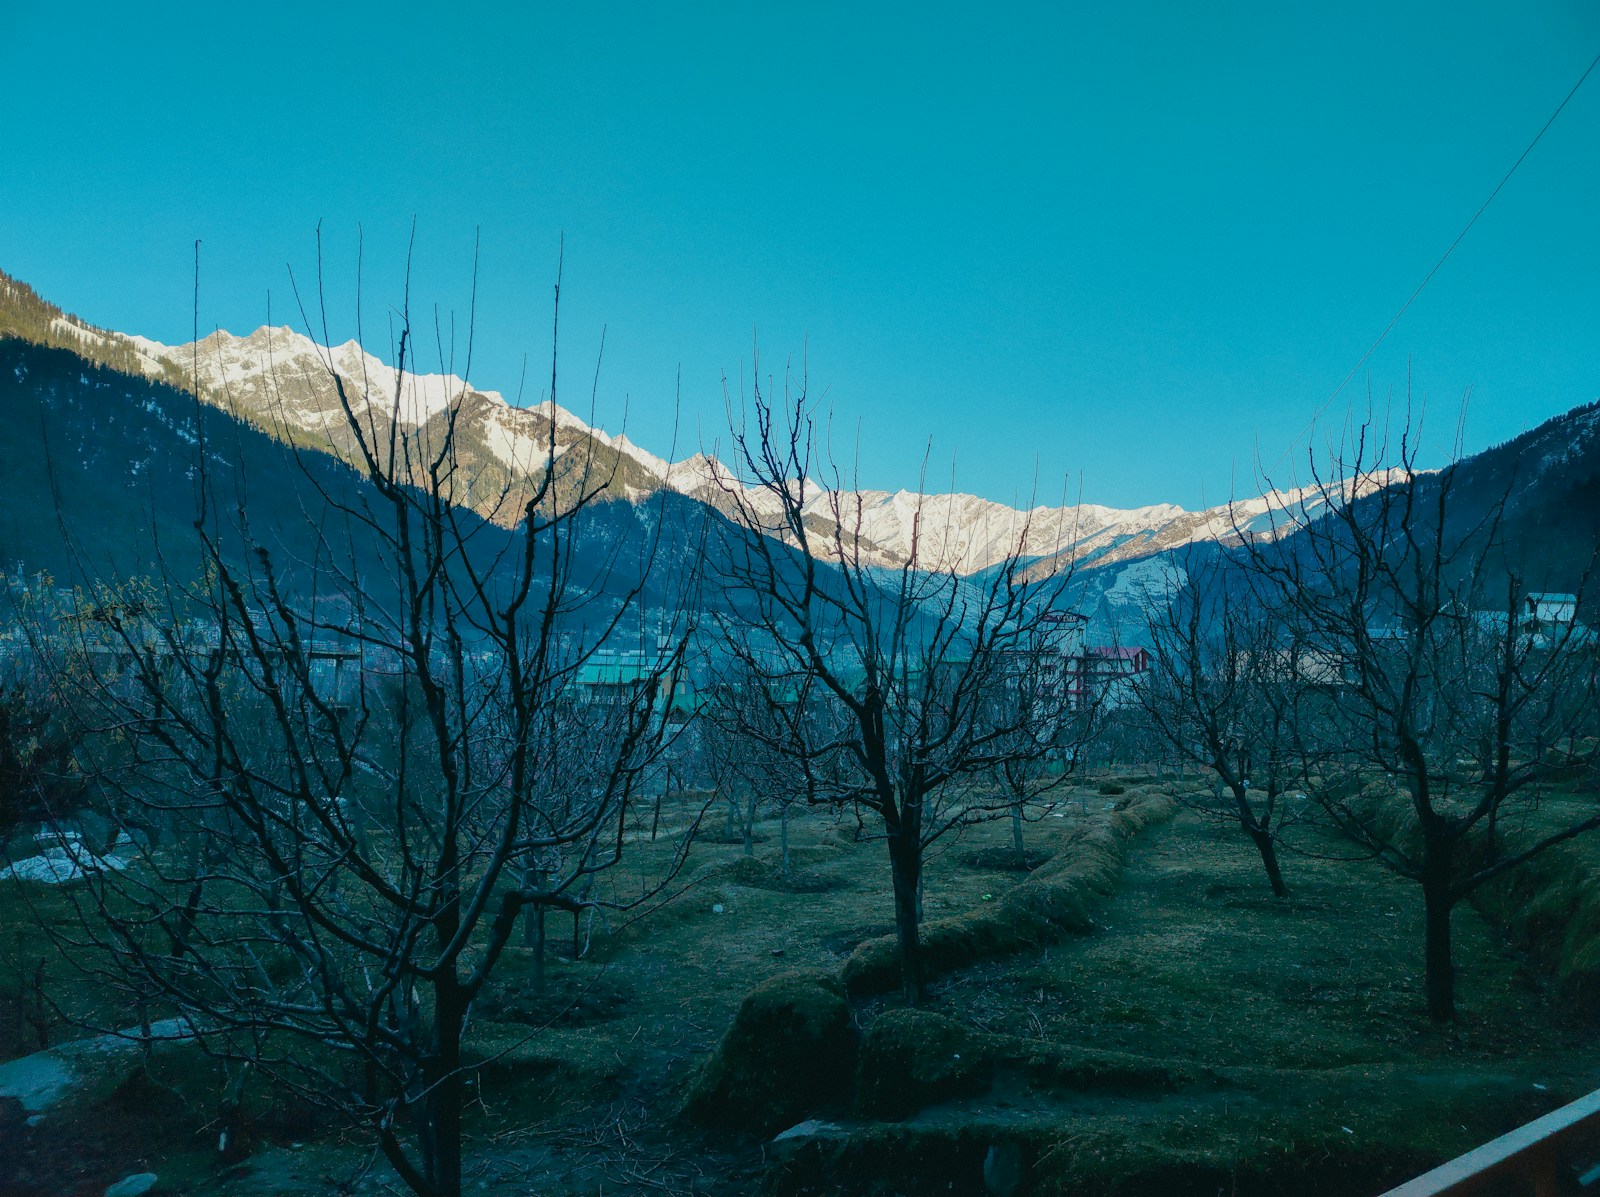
[0,779,1600,1197]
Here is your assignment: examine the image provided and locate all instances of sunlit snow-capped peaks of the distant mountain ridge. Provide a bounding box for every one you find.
[126,326,1401,574]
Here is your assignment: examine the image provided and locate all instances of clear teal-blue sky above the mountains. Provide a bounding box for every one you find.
[0,0,1600,506]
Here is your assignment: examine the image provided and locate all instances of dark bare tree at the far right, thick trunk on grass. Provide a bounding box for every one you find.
[1246,427,1600,1021]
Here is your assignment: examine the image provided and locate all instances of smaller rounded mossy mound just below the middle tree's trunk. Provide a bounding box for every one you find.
[856,1010,995,1119]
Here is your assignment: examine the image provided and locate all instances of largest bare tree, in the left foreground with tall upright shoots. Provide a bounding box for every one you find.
[36,257,693,1197]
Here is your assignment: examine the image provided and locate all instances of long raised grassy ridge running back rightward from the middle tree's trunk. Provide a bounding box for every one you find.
[843,797,1178,994]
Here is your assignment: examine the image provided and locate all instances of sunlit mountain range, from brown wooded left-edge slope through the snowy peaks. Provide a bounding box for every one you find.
[0,267,1388,574]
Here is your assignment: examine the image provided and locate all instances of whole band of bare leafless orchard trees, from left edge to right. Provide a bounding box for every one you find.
[9,254,1600,1197]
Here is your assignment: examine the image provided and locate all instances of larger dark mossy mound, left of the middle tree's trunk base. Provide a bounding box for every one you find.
[683,968,856,1135]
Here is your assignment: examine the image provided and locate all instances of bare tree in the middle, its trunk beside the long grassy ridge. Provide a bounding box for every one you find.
[712,364,1070,1003]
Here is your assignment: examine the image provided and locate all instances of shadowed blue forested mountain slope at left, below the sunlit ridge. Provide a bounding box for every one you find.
[0,338,707,636]
